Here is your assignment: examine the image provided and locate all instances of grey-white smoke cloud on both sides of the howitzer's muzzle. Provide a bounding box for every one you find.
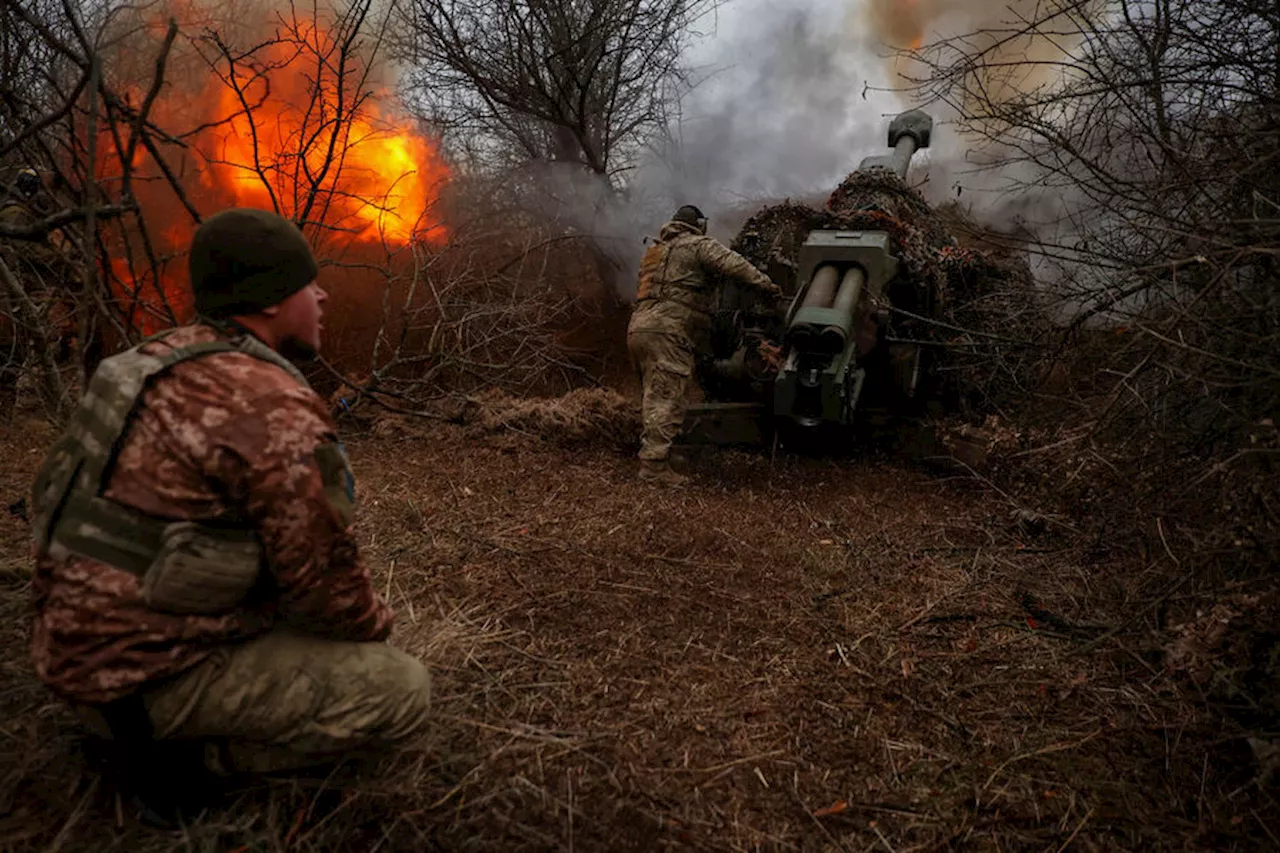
[635,0,1071,237]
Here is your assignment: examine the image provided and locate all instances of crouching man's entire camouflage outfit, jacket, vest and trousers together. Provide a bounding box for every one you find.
[32,325,429,770]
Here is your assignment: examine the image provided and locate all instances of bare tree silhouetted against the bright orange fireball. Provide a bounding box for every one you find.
[183,0,431,245]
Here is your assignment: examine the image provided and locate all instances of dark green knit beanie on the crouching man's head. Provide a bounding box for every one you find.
[188,207,319,318]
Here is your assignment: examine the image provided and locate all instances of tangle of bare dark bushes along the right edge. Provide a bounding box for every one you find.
[911,0,1280,754]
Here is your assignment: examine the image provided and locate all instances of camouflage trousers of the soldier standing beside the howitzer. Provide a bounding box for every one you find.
[627,330,695,461]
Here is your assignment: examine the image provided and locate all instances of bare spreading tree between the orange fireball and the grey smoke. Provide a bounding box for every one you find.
[394,0,721,292]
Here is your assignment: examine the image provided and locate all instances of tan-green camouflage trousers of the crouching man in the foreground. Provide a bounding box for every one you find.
[81,631,430,772]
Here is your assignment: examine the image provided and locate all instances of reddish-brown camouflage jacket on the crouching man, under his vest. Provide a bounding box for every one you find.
[32,325,393,703]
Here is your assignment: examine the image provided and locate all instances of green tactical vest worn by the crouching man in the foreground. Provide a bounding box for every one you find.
[32,332,311,613]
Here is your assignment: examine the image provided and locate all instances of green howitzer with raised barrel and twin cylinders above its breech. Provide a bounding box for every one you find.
[686,110,933,444]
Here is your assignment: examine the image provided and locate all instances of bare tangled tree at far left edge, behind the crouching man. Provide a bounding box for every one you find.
[0,0,186,415]
